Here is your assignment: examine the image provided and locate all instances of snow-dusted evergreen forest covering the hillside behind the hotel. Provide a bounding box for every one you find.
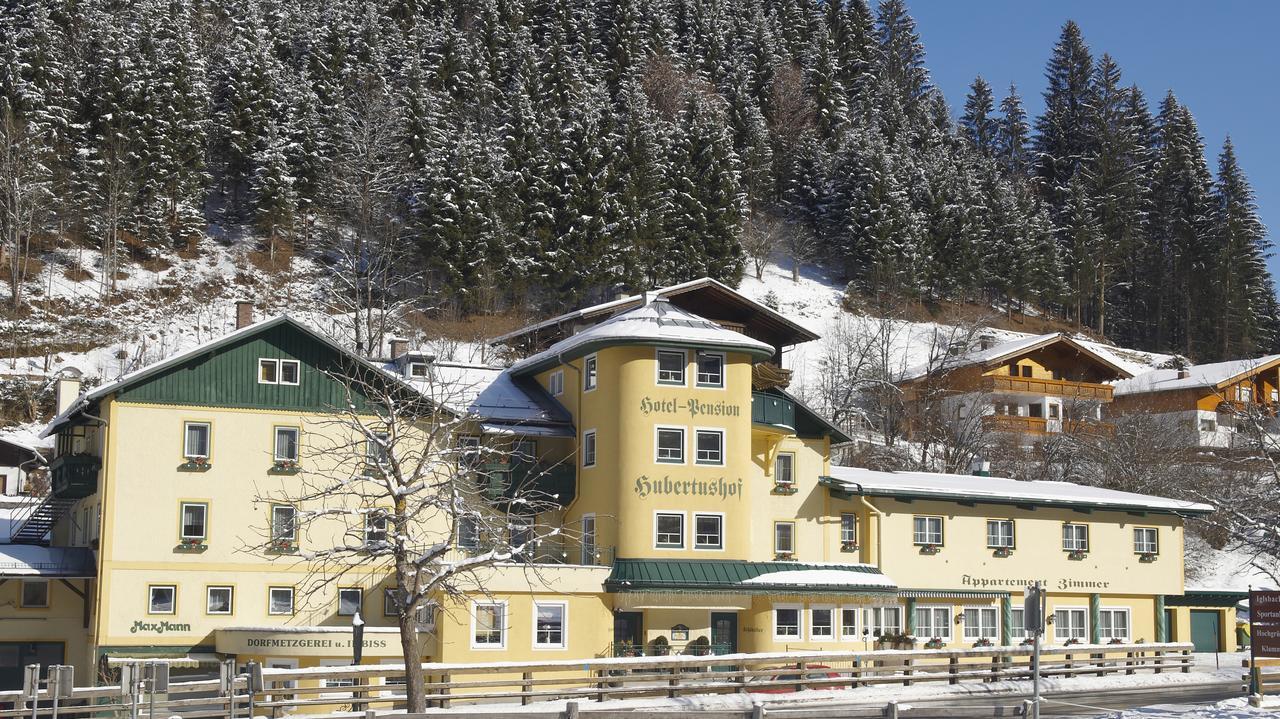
[0,0,1280,361]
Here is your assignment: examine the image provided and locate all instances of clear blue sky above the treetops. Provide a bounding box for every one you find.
[908,0,1280,276]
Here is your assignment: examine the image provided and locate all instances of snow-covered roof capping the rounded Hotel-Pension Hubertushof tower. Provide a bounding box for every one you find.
[511,297,773,375]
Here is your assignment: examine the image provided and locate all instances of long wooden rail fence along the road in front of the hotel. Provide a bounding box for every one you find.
[0,644,1193,719]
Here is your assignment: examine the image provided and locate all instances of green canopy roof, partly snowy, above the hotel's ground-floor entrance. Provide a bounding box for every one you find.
[604,559,896,594]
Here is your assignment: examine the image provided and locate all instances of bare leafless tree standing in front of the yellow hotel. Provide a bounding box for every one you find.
[244,365,571,713]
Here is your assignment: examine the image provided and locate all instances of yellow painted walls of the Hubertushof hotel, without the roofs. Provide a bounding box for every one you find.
[0,298,1234,695]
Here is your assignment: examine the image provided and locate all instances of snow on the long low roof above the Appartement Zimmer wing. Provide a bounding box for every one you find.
[824,467,1213,514]
